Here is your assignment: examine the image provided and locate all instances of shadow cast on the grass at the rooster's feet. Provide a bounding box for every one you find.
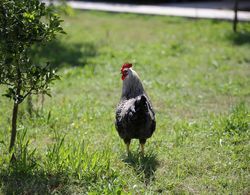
[123,152,159,185]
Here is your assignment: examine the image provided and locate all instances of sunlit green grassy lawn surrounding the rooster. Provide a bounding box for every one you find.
[0,11,250,194]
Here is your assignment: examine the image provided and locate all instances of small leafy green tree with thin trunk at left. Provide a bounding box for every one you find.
[0,0,64,157]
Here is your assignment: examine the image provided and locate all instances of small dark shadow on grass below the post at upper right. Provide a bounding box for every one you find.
[228,32,250,45]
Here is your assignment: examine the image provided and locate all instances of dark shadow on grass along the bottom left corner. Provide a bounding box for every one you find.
[0,172,69,194]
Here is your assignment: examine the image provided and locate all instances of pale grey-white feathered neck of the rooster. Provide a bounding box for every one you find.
[122,69,144,99]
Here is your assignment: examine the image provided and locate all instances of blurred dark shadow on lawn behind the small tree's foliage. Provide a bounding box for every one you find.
[31,40,97,68]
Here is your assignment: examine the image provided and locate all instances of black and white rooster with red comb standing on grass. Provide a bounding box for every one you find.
[115,63,156,155]
